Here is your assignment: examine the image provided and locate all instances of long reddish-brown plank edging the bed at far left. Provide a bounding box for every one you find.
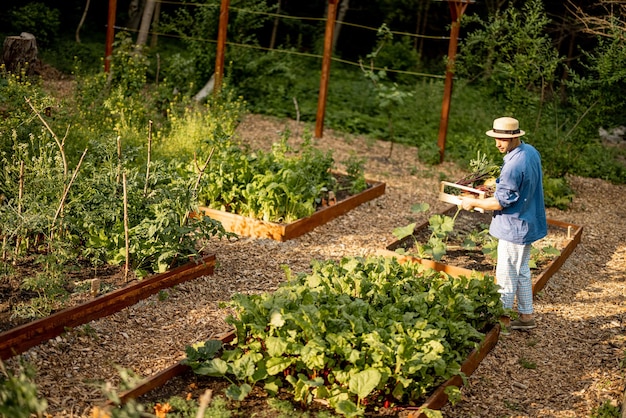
[0,254,215,360]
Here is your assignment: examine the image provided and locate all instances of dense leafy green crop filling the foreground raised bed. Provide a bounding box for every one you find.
[184,258,502,416]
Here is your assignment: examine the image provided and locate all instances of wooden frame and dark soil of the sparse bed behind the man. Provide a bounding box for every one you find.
[379,206,583,295]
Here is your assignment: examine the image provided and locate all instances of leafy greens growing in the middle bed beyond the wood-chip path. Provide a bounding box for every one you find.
[198,132,336,223]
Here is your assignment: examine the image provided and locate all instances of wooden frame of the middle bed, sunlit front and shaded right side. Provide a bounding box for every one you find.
[194,177,385,241]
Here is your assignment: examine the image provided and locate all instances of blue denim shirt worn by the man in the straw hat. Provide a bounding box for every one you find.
[489,142,548,245]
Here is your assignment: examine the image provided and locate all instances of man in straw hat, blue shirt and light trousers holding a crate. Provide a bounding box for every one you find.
[461,117,548,330]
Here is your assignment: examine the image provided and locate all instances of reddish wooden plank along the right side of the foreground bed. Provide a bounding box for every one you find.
[404,324,500,418]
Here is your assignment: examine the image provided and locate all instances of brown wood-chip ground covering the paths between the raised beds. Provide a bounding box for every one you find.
[8,115,626,418]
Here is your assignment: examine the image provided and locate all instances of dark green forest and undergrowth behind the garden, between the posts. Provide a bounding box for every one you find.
[0,0,626,187]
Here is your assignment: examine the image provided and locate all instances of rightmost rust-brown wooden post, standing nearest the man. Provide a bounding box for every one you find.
[437,0,475,163]
